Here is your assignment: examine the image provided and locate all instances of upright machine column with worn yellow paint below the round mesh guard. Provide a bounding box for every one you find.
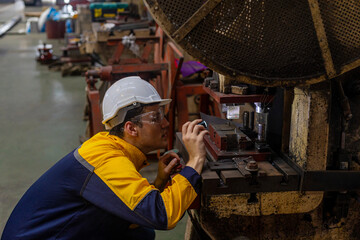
[289,88,330,170]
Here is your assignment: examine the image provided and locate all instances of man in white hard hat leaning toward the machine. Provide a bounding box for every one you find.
[2,77,208,240]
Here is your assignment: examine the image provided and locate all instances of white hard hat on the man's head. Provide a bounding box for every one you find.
[102,76,171,129]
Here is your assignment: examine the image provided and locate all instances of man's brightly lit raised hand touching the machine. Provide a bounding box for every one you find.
[182,119,209,174]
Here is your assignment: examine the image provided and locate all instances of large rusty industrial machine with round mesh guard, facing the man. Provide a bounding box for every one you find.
[145,0,360,239]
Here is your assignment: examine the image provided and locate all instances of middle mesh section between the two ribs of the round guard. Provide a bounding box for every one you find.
[186,0,324,78]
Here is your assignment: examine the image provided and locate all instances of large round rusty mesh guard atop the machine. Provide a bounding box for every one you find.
[145,0,360,86]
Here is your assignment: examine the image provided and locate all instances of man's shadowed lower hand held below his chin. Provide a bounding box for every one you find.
[154,152,181,192]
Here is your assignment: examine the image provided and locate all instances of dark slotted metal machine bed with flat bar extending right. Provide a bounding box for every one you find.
[176,133,360,196]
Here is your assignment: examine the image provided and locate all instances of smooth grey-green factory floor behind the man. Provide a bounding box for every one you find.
[0,4,187,240]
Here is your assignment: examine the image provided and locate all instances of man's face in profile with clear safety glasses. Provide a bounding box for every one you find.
[134,105,169,151]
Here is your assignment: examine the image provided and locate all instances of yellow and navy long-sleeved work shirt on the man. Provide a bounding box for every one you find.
[2,132,201,240]
